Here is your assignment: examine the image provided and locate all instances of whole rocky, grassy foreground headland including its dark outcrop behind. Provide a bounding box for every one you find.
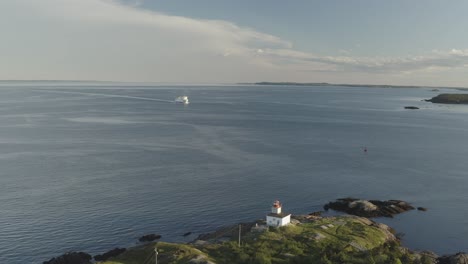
[44,198,468,264]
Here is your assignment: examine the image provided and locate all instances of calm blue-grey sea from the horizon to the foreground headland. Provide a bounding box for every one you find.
[0,83,468,264]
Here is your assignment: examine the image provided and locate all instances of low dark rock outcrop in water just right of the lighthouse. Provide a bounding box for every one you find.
[323,198,414,217]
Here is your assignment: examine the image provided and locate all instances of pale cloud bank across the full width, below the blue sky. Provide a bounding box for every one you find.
[0,0,468,86]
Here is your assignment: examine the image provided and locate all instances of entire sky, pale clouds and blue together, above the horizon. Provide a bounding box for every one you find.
[0,0,468,87]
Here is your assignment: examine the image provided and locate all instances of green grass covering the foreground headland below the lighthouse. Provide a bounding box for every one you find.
[98,216,417,264]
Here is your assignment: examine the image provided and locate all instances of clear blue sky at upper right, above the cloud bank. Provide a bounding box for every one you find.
[141,0,468,56]
